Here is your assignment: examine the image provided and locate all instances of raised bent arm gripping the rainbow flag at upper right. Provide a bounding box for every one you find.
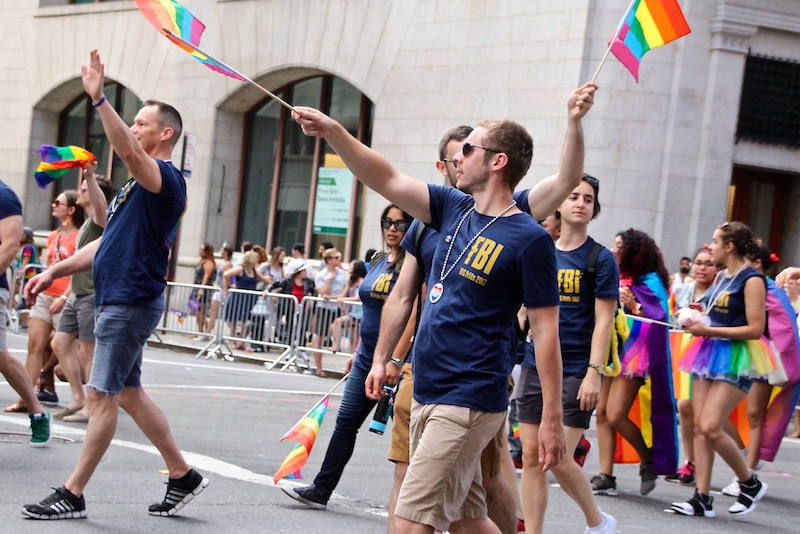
[528,83,597,221]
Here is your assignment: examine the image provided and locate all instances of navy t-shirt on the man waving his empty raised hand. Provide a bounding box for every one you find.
[92,160,186,306]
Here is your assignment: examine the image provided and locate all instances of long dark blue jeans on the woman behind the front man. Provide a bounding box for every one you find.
[314,365,376,499]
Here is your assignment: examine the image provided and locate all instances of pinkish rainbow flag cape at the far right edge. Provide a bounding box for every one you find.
[761,278,800,462]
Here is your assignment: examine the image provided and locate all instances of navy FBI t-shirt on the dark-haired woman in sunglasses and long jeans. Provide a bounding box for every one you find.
[353,255,398,372]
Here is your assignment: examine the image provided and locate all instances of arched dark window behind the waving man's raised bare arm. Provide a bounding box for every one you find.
[54,82,142,198]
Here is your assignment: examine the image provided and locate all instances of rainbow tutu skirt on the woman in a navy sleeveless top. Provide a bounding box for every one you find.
[678,336,775,381]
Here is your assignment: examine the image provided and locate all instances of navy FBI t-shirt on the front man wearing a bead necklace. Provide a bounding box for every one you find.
[414,185,558,412]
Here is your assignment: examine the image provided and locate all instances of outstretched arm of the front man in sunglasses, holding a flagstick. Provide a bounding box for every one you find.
[292,106,431,223]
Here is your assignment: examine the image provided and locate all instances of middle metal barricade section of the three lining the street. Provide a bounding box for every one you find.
[206,289,300,371]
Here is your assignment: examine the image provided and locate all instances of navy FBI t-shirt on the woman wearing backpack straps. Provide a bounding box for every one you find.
[523,237,619,376]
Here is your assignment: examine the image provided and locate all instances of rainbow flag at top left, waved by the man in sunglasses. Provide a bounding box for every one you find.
[136,0,249,82]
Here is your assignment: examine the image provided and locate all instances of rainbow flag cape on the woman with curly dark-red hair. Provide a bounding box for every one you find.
[615,273,678,475]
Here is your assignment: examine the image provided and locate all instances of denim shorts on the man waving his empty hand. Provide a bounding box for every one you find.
[89,296,164,394]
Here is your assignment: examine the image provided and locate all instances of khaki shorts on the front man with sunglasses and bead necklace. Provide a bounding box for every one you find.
[395,401,506,530]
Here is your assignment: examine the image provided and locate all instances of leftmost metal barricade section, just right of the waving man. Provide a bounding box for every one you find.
[155,282,221,356]
